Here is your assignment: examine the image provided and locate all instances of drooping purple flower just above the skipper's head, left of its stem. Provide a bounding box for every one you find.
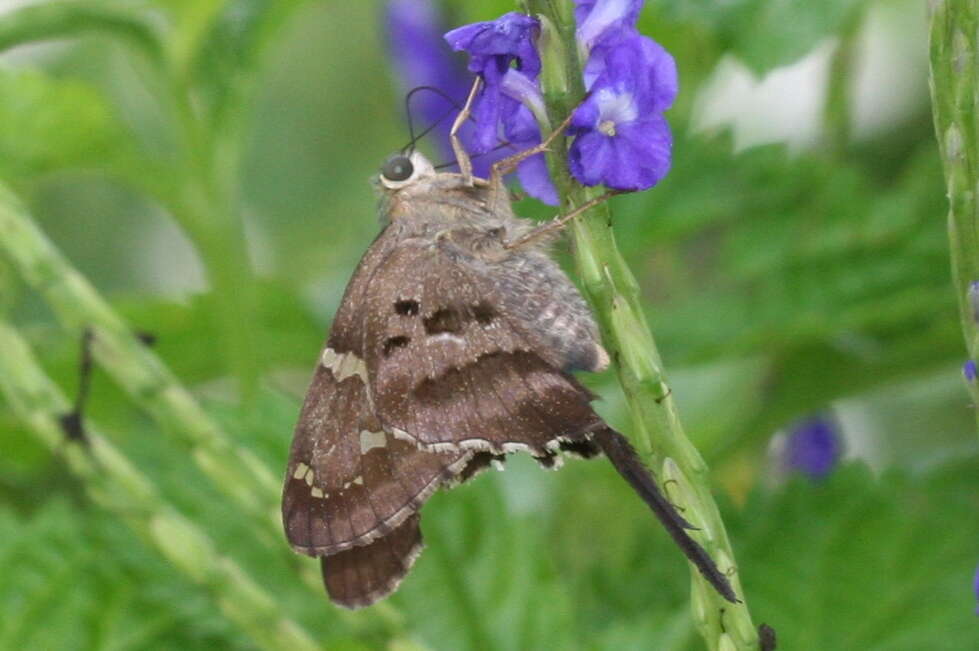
[445,11,541,154]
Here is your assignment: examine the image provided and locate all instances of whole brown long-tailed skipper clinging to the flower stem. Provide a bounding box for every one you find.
[282,88,735,608]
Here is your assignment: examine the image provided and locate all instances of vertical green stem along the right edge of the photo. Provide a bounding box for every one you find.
[929,0,979,438]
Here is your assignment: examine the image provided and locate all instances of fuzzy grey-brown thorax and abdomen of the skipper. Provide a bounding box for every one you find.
[379,154,608,370]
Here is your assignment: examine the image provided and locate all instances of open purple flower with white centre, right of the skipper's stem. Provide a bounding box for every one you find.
[568,35,677,191]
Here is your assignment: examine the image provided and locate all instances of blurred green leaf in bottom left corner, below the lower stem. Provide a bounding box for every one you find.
[0,502,249,650]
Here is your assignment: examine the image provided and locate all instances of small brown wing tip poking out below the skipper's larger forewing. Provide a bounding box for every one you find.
[320,515,422,608]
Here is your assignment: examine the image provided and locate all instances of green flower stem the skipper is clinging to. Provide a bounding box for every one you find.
[526,0,758,650]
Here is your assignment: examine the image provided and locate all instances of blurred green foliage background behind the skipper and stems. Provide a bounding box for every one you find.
[0,0,979,651]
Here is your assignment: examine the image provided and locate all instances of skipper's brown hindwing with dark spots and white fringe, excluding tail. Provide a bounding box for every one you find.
[363,243,603,460]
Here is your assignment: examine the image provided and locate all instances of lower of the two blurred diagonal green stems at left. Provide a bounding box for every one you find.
[0,321,320,651]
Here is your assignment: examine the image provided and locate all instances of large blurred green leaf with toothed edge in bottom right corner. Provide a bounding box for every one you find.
[728,457,979,651]
